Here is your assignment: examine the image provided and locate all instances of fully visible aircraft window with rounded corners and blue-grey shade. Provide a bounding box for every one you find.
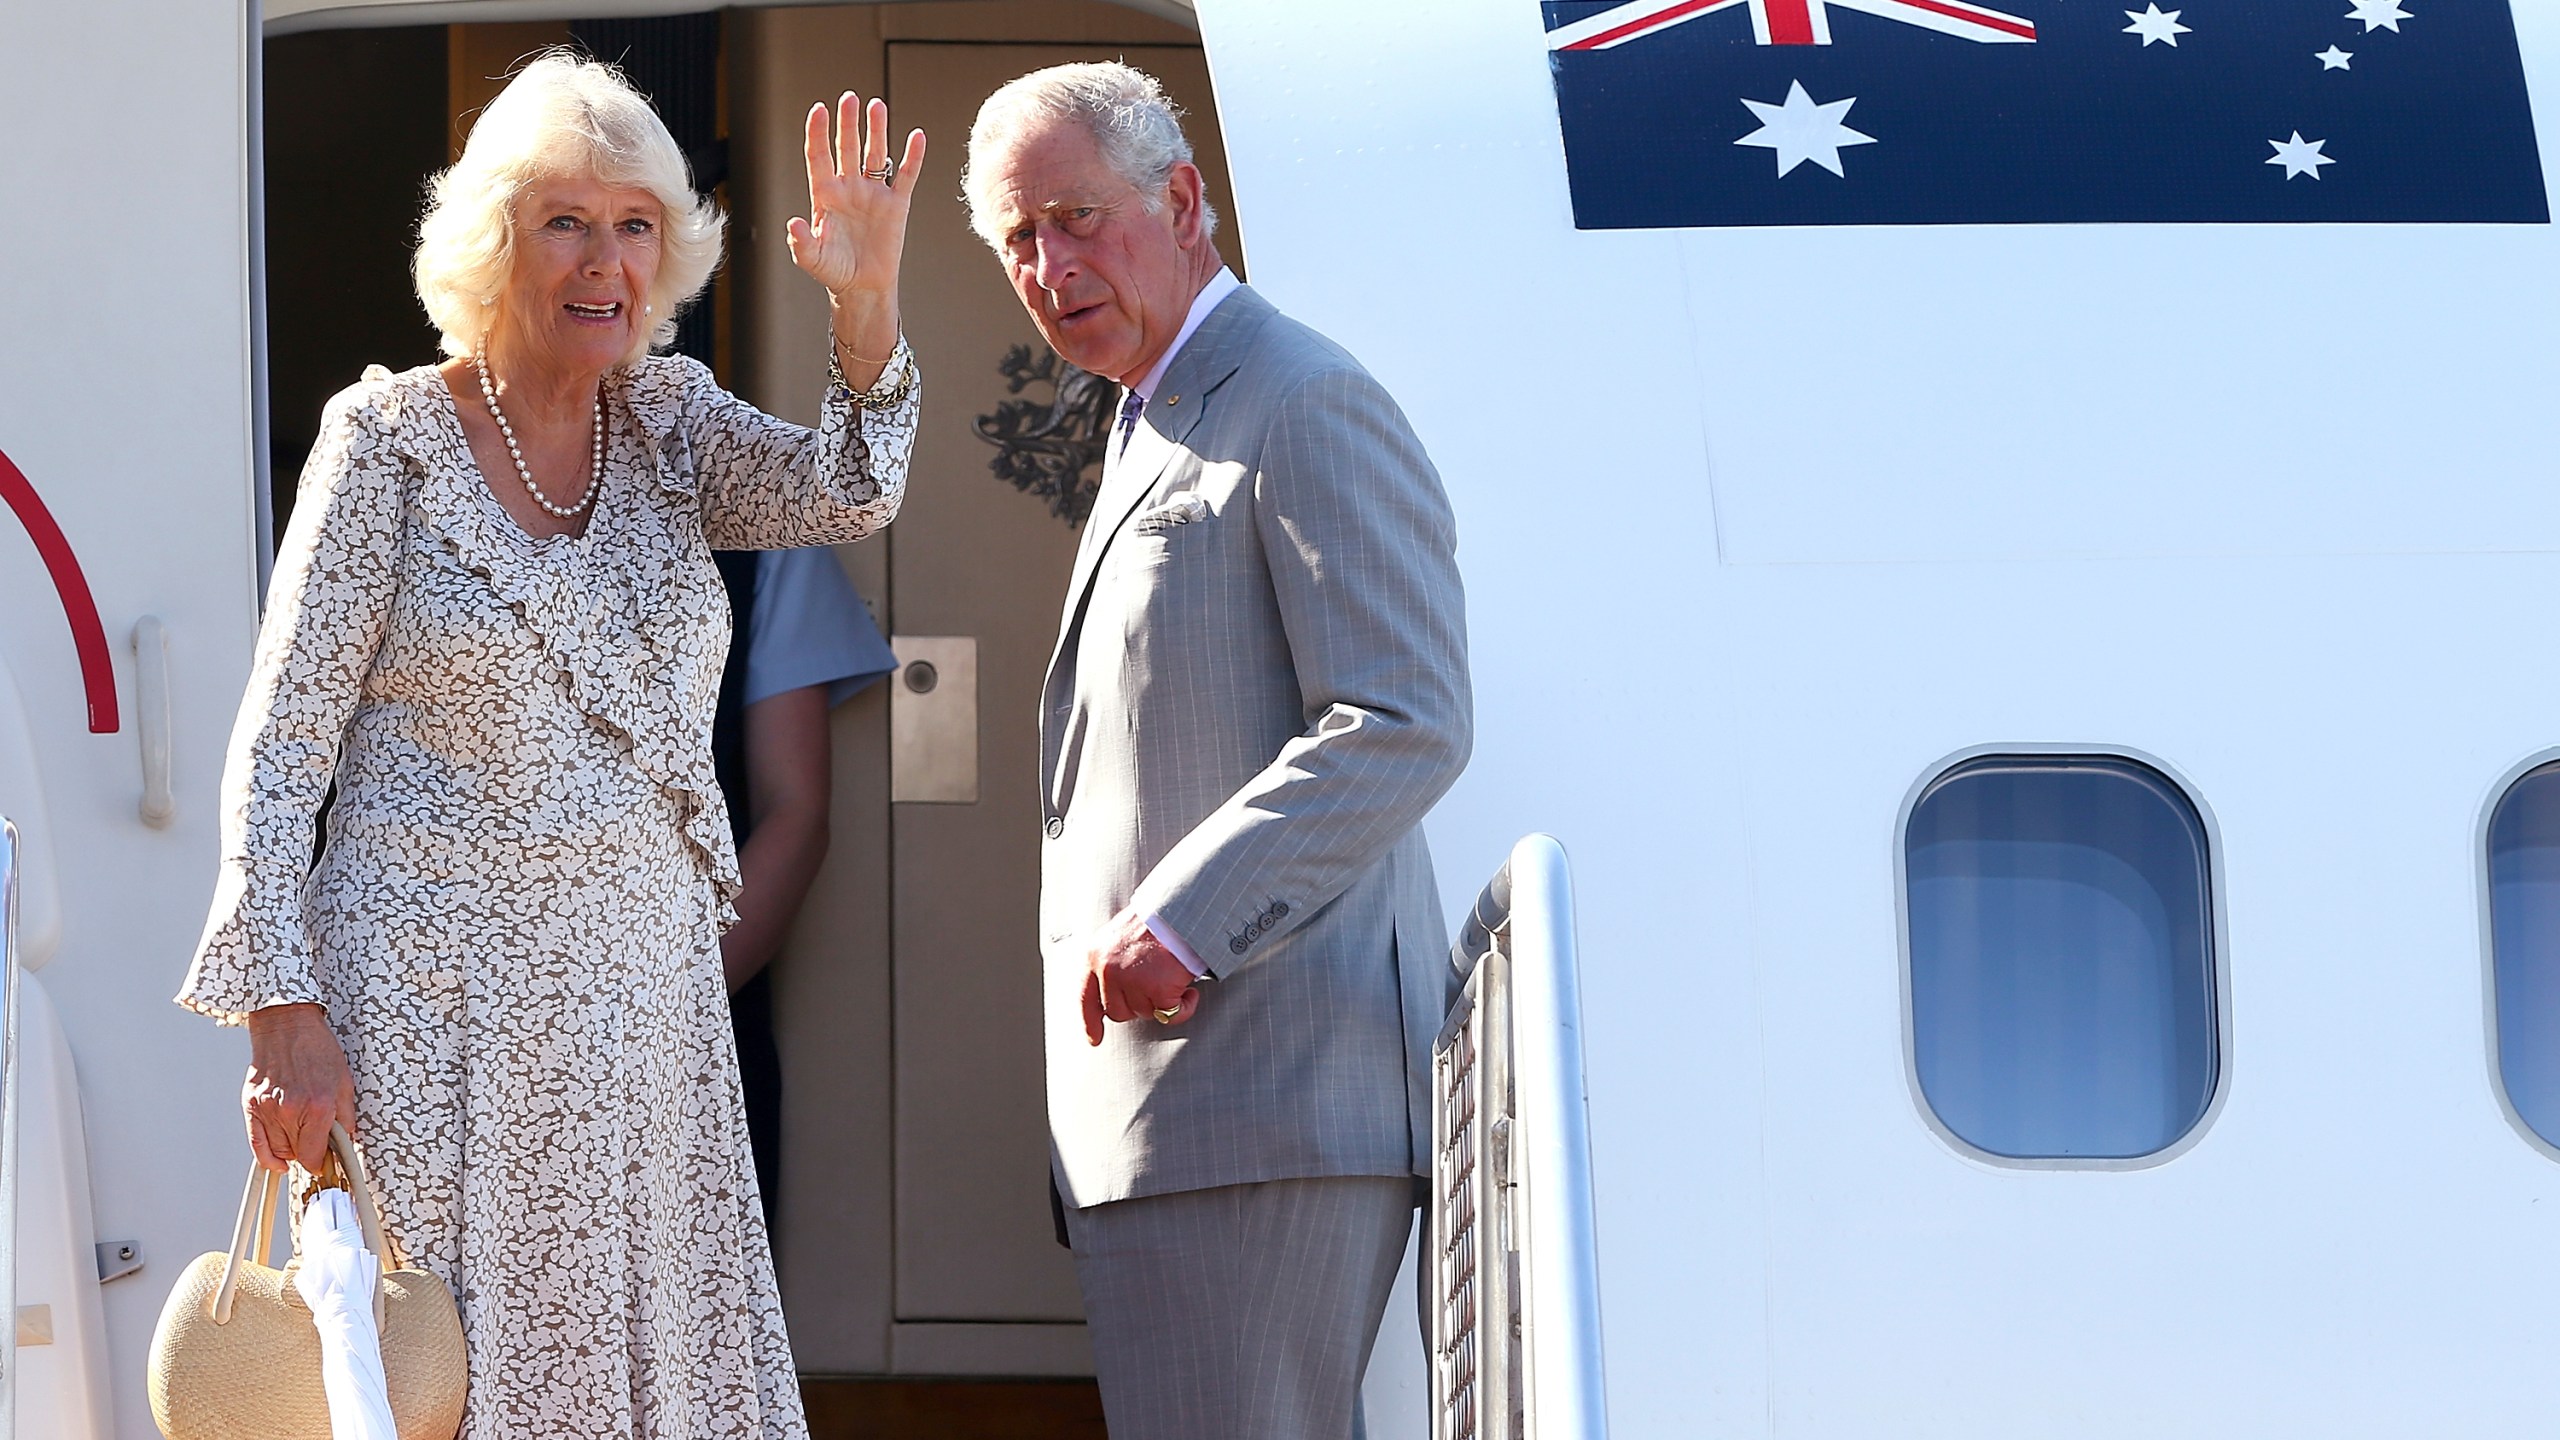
[1902,756,2222,1161]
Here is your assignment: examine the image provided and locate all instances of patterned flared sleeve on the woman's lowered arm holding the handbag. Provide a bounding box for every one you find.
[177,369,402,1025]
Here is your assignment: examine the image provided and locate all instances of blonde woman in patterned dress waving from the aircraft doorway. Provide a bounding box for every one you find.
[179,54,924,1440]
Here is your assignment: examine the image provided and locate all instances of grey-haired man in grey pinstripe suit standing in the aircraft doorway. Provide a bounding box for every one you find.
[965,64,1472,1440]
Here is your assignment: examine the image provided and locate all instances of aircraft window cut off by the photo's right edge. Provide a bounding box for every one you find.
[2488,761,2560,1145]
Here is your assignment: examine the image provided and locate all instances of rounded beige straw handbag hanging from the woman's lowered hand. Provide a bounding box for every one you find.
[151,1125,466,1440]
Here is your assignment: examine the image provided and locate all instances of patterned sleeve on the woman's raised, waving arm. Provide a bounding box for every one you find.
[660,338,924,551]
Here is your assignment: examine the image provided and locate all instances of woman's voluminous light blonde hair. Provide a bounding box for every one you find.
[410,49,727,364]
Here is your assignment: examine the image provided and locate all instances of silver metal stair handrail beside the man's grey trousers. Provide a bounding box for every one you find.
[1431,835,1608,1440]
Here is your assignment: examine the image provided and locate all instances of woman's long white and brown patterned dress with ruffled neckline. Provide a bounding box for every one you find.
[177,343,916,1440]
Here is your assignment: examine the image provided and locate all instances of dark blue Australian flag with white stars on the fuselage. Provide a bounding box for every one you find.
[1544,0,2550,231]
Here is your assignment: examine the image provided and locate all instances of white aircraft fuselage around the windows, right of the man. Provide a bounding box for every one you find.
[1201,0,2560,1440]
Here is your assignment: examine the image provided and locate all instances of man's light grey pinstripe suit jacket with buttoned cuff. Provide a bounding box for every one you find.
[1039,290,1475,1207]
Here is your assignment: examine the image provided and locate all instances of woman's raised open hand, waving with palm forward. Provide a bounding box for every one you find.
[791,90,924,308]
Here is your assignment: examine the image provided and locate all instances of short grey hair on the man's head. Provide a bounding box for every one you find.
[960,59,1219,251]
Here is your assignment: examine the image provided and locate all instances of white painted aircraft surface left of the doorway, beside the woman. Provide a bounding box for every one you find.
[0,3,277,1440]
